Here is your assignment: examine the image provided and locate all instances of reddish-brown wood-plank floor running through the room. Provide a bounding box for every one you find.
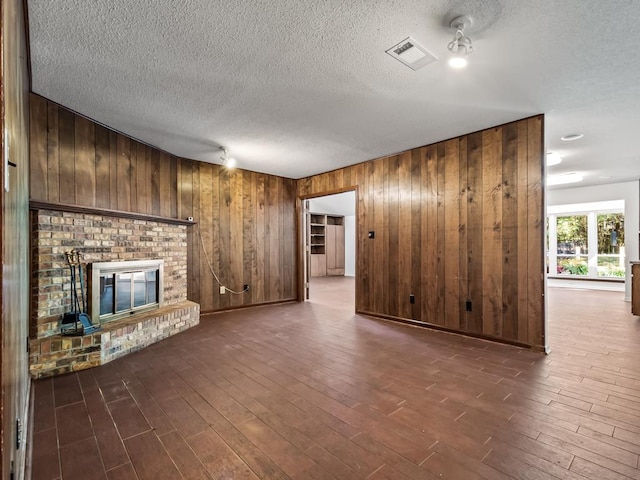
[32,278,640,480]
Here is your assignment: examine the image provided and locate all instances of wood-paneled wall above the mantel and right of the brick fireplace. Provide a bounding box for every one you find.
[30,95,296,312]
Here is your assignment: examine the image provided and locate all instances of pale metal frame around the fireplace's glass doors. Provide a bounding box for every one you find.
[88,259,164,323]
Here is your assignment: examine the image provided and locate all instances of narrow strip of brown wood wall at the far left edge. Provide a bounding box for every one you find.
[0,0,30,478]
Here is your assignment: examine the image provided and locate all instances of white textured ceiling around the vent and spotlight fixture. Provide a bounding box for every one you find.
[28,0,640,185]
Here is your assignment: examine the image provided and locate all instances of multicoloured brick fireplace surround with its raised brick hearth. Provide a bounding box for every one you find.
[29,209,200,378]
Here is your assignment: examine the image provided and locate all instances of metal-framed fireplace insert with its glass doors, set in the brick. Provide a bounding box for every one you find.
[89,260,163,322]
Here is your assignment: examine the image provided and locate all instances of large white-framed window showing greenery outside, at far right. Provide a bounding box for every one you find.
[547,202,625,278]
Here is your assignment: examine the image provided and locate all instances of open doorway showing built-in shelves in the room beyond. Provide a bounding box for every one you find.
[302,190,356,311]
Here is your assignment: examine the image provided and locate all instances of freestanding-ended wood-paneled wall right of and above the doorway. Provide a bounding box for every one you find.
[298,116,545,349]
